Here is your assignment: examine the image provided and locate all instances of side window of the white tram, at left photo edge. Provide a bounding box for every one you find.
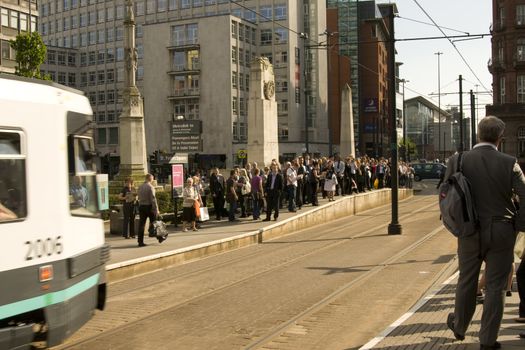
[0,130,27,223]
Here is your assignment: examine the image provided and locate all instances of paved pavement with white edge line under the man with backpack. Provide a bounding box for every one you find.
[359,261,525,350]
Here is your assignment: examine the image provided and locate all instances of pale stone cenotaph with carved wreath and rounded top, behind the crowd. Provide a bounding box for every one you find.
[248,57,279,166]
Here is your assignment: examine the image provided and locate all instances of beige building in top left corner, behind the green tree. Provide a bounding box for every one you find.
[0,0,38,73]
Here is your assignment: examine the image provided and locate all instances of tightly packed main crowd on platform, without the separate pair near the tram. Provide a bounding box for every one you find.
[194,155,414,221]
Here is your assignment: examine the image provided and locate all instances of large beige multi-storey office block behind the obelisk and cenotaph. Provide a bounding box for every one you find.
[40,0,328,171]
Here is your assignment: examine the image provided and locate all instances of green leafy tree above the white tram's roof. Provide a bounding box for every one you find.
[9,32,47,79]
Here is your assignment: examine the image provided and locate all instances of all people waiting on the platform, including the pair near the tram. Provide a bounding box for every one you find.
[119,154,414,246]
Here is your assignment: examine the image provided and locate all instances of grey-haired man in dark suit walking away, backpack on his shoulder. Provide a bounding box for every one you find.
[445,116,525,350]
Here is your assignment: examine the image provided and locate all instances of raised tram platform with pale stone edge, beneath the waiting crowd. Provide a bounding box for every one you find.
[102,189,413,283]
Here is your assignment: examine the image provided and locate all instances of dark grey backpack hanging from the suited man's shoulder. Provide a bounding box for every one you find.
[439,153,479,238]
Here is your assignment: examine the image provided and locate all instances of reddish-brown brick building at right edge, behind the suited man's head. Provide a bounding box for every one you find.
[486,0,525,166]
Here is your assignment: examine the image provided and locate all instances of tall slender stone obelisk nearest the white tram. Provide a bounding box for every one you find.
[118,0,147,180]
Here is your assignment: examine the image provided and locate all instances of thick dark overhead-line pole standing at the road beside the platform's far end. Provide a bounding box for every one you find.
[388,4,401,235]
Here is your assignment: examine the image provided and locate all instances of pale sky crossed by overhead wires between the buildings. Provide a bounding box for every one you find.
[384,0,492,120]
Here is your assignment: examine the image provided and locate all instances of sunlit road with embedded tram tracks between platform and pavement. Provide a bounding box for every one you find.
[55,187,455,350]
